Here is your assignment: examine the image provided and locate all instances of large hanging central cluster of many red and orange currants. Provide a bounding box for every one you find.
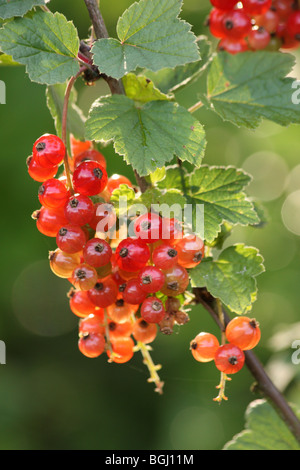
[27,134,204,363]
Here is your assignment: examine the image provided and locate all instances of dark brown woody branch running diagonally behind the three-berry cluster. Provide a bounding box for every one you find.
[194,288,300,443]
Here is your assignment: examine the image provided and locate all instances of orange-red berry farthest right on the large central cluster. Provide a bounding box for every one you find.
[176,235,204,269]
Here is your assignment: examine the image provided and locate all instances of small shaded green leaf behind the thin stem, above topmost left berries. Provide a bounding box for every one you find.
[46,84,85,141]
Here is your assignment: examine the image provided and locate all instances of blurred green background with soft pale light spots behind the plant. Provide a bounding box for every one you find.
[0,0,300,450]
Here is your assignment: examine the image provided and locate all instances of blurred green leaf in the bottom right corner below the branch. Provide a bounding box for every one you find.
[224,400,300,450]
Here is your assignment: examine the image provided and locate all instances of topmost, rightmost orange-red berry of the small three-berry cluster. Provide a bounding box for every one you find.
[225,316,261,351]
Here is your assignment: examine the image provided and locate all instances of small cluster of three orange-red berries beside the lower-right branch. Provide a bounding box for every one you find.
[190,316,261,375]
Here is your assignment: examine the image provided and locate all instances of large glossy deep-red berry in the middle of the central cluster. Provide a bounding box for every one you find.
[116,238,150,272]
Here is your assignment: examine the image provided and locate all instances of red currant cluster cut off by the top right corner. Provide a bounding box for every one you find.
[208,0,300,54]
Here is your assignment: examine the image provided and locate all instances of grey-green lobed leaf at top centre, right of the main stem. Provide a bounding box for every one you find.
[92,0,199,78]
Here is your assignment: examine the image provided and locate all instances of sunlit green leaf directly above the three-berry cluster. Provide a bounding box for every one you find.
[190,244,264,314]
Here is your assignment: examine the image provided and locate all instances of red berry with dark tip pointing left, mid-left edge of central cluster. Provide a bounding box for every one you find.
[32,207,68,238]
